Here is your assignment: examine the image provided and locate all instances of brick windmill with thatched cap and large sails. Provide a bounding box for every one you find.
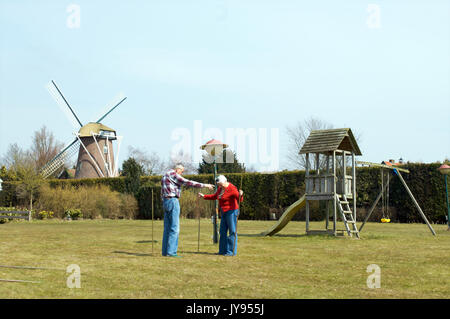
[41,80,126,178]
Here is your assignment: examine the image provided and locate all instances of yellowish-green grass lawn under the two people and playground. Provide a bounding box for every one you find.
[0,219,450,299]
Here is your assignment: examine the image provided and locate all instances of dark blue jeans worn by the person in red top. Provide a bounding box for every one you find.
[219,209,239,256]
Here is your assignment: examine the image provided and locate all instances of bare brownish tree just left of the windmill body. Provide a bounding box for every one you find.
[29,125,64,169]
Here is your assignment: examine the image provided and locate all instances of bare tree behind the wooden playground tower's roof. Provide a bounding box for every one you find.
[286,117,333,169]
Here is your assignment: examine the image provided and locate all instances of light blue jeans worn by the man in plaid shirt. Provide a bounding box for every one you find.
[162,197,180,256]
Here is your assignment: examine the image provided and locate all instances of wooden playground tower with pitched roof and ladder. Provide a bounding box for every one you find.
[300,128,362,238]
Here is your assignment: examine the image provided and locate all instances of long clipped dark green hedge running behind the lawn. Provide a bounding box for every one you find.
[0,164,447,223]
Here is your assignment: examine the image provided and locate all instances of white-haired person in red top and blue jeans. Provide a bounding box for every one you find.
[198,175,244,256]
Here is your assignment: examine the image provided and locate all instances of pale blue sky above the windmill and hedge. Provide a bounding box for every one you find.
[0,0,450,169]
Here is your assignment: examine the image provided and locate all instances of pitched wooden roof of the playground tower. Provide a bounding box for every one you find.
[300,128,362,155]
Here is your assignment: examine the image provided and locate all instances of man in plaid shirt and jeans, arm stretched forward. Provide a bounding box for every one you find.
[161,165,214,257]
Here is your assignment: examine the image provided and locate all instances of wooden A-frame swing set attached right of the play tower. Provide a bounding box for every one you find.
[357,161,436,236]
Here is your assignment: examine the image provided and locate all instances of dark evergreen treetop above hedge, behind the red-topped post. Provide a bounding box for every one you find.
[198,149,245,174]
